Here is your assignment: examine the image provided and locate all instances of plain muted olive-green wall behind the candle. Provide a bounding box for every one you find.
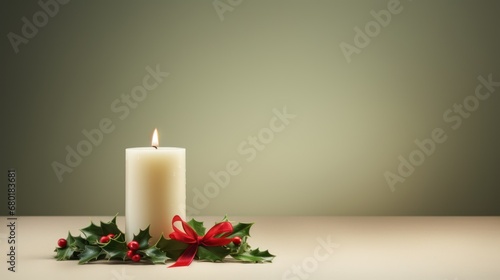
[0,0,500,215]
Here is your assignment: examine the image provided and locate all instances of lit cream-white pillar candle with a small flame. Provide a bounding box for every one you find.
[125,129,186,245]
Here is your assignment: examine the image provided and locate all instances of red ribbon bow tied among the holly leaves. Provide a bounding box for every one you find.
[169,215,233,267]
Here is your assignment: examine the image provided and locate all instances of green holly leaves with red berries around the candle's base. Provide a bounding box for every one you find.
[55,216,275,264]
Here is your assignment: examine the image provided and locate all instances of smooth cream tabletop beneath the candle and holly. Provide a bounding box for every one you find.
[0,216,500,280]
